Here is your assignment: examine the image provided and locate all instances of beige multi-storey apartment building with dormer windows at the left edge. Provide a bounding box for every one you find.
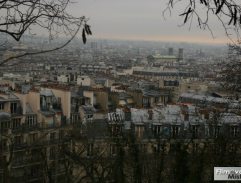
[0,89,70,182]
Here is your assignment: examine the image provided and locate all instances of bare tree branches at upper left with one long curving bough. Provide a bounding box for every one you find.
[0,0,92,65]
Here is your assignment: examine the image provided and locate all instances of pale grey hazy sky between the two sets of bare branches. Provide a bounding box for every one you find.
[70,0,230,43]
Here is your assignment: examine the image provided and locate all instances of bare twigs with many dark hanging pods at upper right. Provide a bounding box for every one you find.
[163,0,241,41]
